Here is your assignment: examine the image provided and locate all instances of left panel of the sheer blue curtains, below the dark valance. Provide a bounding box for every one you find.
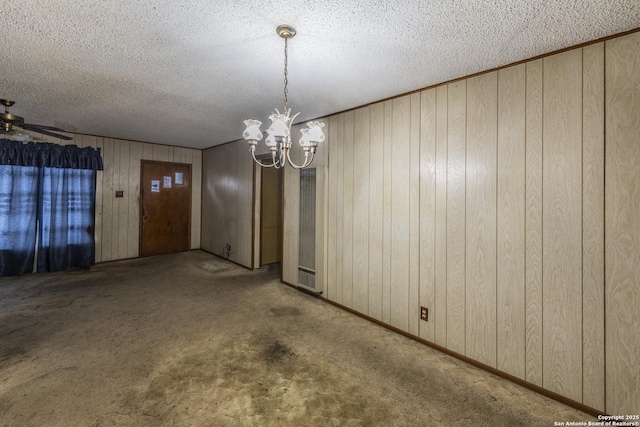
[0,165,38,276]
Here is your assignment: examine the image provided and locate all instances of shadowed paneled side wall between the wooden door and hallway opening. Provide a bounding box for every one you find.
[202,140,254,268]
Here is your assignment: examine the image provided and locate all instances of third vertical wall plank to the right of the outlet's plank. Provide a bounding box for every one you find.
[458,72,498,367]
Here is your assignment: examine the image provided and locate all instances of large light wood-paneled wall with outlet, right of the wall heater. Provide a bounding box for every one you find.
[312,33,640,414]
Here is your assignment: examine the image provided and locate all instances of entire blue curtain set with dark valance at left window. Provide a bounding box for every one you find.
[0,139,103,276]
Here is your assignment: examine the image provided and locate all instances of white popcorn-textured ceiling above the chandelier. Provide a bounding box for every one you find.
[0,0,640,148]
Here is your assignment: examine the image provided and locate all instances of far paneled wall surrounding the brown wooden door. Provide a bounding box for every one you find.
[16,132,202,262]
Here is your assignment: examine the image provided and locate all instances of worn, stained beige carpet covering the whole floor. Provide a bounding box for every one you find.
[0,251,593,427]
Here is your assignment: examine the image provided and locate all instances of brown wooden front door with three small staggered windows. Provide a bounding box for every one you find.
[140,160,191,256]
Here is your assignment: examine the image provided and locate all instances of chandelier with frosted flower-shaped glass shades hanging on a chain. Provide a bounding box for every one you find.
[242,25,325,169]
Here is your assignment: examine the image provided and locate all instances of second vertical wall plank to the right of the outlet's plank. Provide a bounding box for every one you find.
[447,80,467,354]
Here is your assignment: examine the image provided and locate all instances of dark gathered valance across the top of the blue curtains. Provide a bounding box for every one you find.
[0,139,103,170]
